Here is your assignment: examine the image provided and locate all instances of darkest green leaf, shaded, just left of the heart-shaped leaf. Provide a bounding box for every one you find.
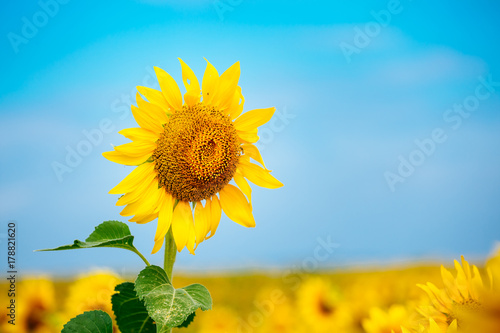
[111,282,156,333]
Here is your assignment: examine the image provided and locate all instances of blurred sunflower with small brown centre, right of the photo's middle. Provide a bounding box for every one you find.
[297,278,352,332]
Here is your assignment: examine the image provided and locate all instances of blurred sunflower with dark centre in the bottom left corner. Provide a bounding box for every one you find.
[0,278,62,333]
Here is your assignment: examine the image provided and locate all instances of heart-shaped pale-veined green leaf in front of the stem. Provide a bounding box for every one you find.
[135,266,212,330]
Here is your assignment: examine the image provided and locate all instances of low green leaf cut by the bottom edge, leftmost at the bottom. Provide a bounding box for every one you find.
[61,310,113,333]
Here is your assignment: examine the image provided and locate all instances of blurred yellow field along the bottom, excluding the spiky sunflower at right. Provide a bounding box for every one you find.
[0,252,500,333]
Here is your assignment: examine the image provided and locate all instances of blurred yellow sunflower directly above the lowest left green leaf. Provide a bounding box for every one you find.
[64,271,123,332]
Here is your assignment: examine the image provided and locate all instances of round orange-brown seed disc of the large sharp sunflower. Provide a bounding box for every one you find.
[153,103,240,202]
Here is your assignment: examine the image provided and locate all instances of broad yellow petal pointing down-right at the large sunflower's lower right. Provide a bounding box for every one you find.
[219,184,255,227]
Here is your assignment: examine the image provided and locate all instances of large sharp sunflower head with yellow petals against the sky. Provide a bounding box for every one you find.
[103,59,283,254]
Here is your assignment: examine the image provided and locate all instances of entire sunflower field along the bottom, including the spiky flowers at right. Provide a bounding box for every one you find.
[0,248,500,333]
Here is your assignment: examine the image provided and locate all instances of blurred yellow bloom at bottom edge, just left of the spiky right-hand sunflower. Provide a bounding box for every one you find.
[363,304,410,333]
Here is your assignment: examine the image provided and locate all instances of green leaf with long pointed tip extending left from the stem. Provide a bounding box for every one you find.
[36,221,149,266]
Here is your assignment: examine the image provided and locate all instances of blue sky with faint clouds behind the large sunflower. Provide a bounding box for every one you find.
[0,0,500,274]
